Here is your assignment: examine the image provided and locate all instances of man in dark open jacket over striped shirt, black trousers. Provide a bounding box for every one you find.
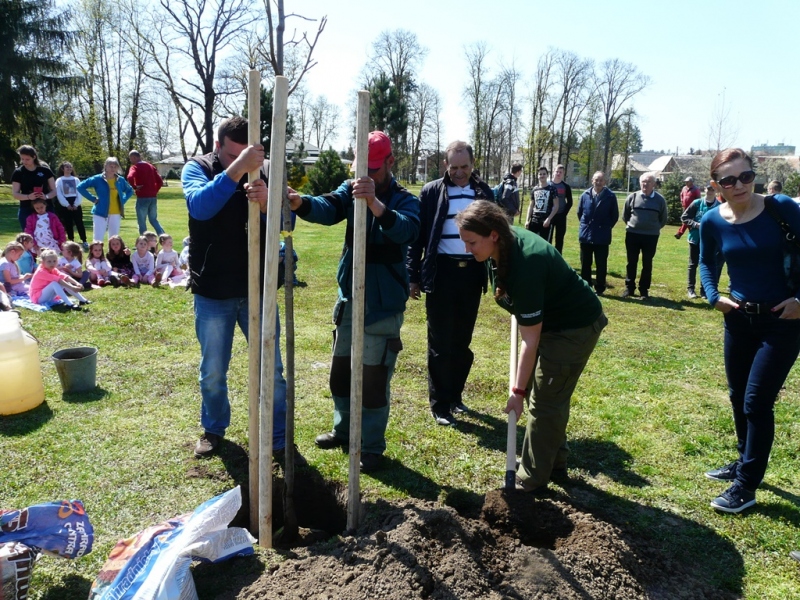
[407,141,494,426]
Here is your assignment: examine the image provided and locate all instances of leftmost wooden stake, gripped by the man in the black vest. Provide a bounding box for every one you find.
[247,69,261,536]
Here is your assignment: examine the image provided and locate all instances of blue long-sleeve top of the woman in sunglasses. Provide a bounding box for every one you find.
[700,198,800,306]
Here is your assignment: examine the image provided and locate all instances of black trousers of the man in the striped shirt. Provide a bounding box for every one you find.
[425,255,486,414]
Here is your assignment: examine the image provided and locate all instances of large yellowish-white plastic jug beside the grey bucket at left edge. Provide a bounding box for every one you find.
[0,312,44,415]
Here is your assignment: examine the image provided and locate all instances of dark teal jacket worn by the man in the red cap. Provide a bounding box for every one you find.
[295,178,419,325]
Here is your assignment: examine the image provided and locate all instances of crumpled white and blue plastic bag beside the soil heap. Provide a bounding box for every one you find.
[89,487,256,600]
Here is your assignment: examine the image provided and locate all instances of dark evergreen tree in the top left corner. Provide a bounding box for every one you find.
[0,0,76,180]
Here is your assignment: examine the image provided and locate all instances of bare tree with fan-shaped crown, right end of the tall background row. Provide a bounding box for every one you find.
[595,58,650,173]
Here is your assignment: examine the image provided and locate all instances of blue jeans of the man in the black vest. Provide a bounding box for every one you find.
[194,294,286,450]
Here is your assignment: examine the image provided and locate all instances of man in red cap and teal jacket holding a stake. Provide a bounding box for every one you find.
[289,131,419,472]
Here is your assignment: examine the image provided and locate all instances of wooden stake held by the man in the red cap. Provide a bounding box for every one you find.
[347,90,369,530]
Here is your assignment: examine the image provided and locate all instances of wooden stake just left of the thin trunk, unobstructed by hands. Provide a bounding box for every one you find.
[258,75,289,548]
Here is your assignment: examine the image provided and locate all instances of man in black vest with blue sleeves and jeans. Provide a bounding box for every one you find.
[181,117,305,464]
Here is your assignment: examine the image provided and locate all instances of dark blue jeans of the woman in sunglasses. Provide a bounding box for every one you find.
[725,309,800,490]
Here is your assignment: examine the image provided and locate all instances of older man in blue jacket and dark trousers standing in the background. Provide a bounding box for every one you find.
[578,171,619,295]
